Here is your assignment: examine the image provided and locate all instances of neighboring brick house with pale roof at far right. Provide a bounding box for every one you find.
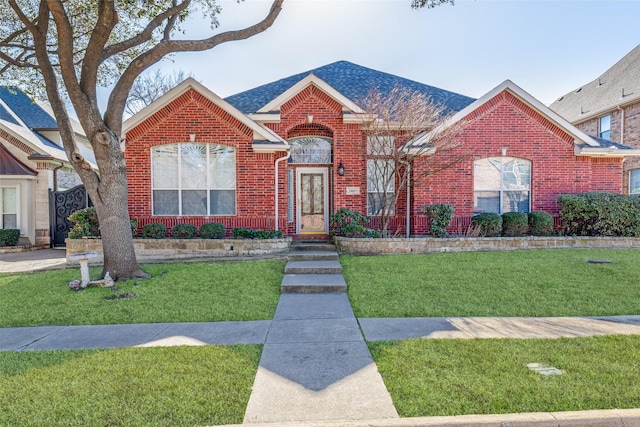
[549,45,640,194]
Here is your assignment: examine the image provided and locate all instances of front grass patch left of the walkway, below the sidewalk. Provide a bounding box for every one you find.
[0,346,261,426]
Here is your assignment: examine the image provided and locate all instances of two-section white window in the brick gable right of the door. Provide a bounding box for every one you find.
[473,157,531,214]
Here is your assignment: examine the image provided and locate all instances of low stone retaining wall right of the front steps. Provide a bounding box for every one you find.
[334,236,640,255]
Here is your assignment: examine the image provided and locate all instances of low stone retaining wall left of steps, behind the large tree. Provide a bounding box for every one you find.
[66,238,291,264]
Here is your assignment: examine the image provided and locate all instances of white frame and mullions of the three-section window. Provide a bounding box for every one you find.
[150,142,238,217]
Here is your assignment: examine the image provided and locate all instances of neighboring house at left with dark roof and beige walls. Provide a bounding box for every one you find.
[0,87,95,245]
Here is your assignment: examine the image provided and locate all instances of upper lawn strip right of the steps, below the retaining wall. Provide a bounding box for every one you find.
[340,249,640,317]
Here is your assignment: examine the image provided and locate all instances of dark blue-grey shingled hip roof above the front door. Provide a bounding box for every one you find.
[225,61,475,114]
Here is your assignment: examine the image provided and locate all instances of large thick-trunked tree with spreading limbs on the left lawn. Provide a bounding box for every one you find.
[0,0,284,279]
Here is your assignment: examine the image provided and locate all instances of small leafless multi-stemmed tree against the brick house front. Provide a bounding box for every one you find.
[361,86,470,236]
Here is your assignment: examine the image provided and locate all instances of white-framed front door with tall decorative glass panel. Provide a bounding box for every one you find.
[296,168,329,234]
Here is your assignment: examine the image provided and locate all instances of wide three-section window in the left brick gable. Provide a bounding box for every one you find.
[151,143,236,216]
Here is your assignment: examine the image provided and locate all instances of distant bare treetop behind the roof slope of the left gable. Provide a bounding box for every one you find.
[125,70,193,116]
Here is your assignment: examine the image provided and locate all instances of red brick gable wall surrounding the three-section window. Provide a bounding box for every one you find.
[125,86,275,227]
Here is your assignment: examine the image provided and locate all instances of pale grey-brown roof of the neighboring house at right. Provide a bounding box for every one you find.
[549,45,640,123]
